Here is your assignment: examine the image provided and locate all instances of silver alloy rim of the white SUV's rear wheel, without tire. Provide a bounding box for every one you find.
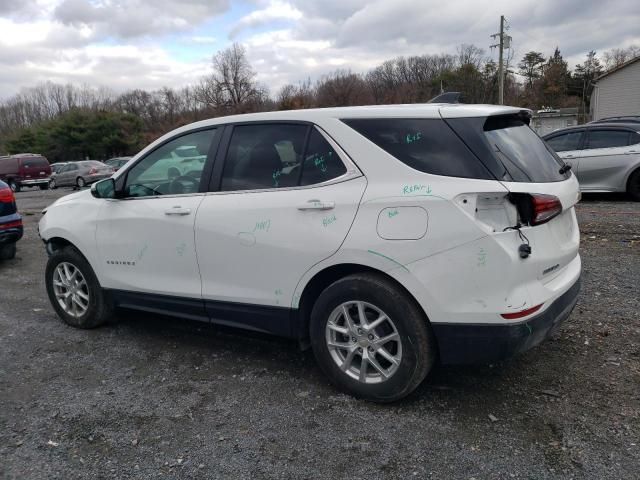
[325,301,402,384]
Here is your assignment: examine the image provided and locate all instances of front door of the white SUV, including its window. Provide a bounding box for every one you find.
[96,129,220,304]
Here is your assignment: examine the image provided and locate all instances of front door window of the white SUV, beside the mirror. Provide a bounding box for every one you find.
[125,129,216,197]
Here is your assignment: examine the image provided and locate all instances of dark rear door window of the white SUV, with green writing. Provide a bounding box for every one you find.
[221,124,347,191]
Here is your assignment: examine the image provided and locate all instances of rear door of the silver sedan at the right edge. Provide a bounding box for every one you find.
[578,128,637,191]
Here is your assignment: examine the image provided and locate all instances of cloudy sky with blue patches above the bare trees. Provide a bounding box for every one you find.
[0,0,640,98]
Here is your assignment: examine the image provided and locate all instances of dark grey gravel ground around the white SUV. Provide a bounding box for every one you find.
[0,190,640,479]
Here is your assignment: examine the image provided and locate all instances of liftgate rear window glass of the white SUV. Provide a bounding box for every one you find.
[483,115,569,183]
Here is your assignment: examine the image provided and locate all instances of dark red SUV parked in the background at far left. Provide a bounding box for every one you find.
[0,153,51,192]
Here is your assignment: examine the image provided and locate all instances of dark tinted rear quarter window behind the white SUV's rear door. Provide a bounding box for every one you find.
[343,118,491,179]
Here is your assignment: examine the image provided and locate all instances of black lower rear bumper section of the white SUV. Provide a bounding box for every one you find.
[432,277,580,365]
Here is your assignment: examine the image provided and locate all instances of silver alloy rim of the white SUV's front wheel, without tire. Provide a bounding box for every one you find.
[53,262,89,318]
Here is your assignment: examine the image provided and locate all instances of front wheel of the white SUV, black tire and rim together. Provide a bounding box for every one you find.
[45,247,113,328]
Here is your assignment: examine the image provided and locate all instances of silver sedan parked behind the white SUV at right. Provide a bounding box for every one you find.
[543,123,640,201]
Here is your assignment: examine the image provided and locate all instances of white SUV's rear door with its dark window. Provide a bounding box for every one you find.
[196,123,366,334]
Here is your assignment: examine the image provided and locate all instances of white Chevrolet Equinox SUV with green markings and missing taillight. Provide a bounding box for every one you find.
[39,104,581,402]
